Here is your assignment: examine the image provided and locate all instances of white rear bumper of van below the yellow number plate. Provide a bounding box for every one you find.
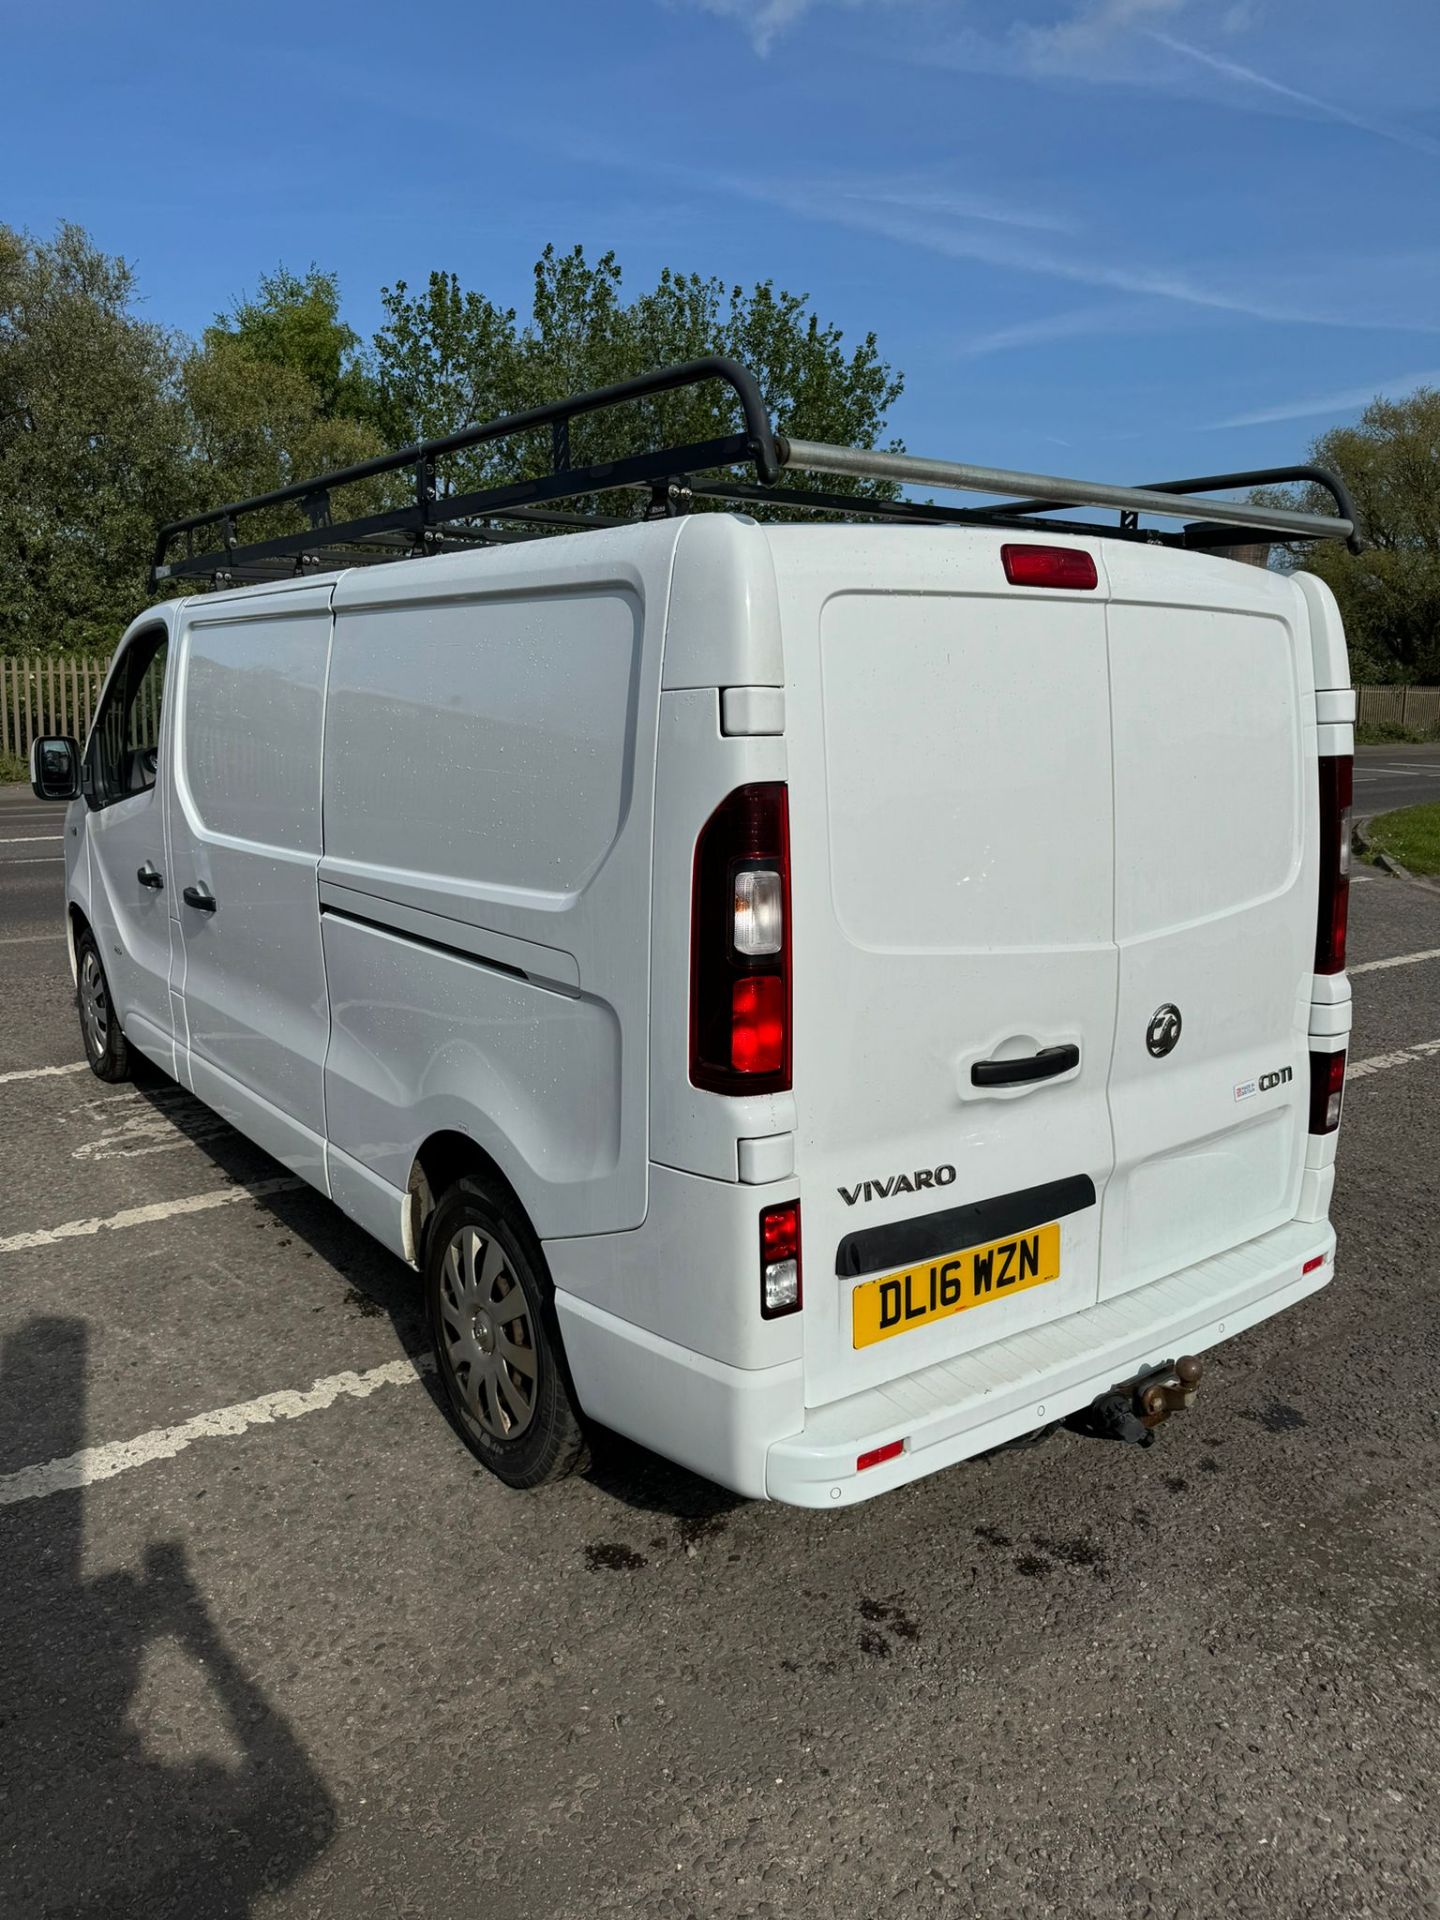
[766,1219,1334,1507]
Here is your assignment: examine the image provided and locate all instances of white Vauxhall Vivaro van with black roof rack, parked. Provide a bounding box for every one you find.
[33,363,1356,1507]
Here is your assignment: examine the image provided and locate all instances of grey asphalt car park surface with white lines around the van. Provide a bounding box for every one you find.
[0,768,1440,1920]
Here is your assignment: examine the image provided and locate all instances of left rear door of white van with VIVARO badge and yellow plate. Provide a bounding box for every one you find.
[772,528,1119,1405]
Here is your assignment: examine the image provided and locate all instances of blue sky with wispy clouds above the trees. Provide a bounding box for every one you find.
[0,0,1440,480]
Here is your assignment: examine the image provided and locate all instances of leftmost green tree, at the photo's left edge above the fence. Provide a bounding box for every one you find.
[0,225,190,653]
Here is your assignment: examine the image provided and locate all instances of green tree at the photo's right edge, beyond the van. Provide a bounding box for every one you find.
[1284,386,1440,682]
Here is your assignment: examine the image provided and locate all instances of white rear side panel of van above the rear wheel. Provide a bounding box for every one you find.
[319,524,676,1236]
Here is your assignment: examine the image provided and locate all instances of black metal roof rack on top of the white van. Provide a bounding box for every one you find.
[150,355,1363,586]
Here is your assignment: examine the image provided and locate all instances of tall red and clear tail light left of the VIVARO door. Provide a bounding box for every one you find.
[689,781,791,1092]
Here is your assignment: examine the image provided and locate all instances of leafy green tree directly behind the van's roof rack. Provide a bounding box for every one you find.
[374,246,902,497]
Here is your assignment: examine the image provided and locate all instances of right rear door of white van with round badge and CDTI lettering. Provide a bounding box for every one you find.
[1100,556,1319,1298]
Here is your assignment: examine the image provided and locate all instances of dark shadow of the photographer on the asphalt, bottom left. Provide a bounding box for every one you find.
[0,1317,336,1920]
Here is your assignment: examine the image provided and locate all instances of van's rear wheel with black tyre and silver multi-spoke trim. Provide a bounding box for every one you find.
[424,1179,584,1488]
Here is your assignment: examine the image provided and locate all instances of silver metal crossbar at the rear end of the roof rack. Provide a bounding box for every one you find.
[776,438,1359,541]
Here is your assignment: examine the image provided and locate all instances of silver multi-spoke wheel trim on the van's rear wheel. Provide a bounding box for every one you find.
[440,1227,540,1442]
